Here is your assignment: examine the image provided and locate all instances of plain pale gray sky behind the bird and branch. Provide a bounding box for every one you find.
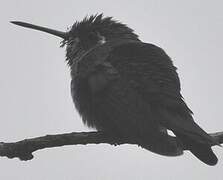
[0,0,223,180]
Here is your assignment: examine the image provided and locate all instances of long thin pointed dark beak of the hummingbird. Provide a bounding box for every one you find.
[11,21,68,40]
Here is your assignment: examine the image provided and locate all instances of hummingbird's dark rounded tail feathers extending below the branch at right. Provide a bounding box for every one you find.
[174,132,218,166]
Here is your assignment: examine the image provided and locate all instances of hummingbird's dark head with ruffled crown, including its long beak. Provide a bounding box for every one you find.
[12,14,139,66]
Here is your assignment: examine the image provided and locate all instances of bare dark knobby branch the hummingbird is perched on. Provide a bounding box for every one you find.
[0,132,223,160]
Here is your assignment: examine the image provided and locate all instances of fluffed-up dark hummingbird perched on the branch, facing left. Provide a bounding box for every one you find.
[12,14,218,165]
